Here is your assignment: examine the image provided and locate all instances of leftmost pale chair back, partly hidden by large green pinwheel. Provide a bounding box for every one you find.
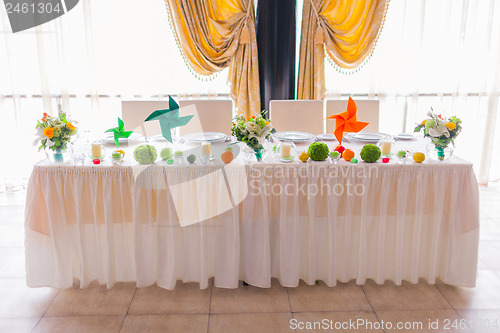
[122,100,168,136]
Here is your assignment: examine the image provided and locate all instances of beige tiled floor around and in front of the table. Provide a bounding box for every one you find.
[0,186,500,333]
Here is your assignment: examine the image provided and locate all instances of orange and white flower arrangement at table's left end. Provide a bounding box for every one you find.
[35,112,77,151]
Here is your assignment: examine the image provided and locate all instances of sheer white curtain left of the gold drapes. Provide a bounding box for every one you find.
[0,0,229,190]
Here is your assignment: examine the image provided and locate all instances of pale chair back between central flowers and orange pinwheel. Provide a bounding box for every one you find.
[269,100,325,135]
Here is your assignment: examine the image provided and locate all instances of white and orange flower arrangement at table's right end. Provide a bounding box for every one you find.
[415,108,462,149]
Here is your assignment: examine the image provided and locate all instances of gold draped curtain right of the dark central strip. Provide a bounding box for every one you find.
[297,0,389,99]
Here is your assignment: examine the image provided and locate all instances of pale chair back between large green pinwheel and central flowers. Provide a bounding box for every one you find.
[179,99,233,136]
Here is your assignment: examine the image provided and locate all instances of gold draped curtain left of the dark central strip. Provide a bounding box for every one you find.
[165,0,260,116]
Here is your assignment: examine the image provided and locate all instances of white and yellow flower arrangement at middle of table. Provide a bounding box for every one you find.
[231,111,276,152]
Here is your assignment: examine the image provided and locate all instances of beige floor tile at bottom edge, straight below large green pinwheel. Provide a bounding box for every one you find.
[120,314,208,333]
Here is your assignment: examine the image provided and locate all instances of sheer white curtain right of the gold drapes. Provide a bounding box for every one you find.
[326,0,500,183]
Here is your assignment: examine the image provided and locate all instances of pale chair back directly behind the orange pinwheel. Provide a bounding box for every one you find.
[326,100,380,133]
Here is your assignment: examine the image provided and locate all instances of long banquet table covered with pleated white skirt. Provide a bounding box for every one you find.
[25,137,479,289]
